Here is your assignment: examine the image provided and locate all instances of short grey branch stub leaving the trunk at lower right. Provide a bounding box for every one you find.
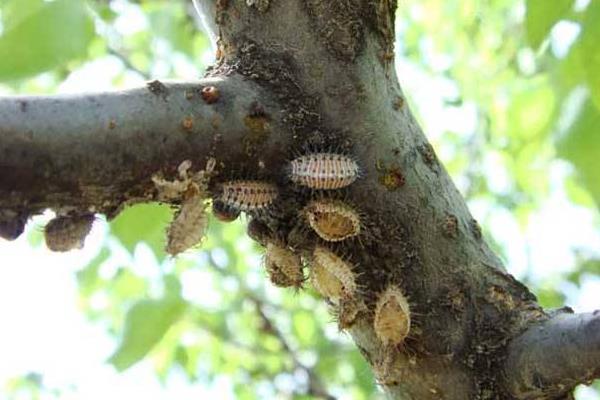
[506,310,600,399]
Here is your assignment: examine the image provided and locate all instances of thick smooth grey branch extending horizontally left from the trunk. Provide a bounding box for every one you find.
[0,75,286,219]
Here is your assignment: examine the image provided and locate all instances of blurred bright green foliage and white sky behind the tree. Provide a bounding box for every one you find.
[0,0,600,400]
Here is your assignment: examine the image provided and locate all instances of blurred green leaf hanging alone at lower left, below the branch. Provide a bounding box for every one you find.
[108,296,186,371]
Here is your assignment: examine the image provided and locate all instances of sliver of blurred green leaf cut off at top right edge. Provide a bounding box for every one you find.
[580,1,600,109]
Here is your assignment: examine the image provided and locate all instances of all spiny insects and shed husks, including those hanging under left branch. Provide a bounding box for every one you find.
[39,152,410,356]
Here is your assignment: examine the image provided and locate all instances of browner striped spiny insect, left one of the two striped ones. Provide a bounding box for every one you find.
[216,180,279,212]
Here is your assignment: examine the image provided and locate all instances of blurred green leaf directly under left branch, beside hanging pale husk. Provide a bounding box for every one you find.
[110,204,173,261]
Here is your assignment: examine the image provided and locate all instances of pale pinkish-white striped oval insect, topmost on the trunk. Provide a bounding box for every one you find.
[289,153,360,190]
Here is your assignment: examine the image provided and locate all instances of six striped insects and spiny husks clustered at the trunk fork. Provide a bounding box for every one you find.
[213,153,410,346]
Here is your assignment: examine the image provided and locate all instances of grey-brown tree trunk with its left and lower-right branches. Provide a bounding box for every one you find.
[0,0,600,400]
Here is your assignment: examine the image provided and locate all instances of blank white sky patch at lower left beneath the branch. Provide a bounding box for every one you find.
[0,218,239,400]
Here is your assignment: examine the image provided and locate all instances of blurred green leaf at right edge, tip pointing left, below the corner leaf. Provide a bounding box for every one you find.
[556,101,600,207]
